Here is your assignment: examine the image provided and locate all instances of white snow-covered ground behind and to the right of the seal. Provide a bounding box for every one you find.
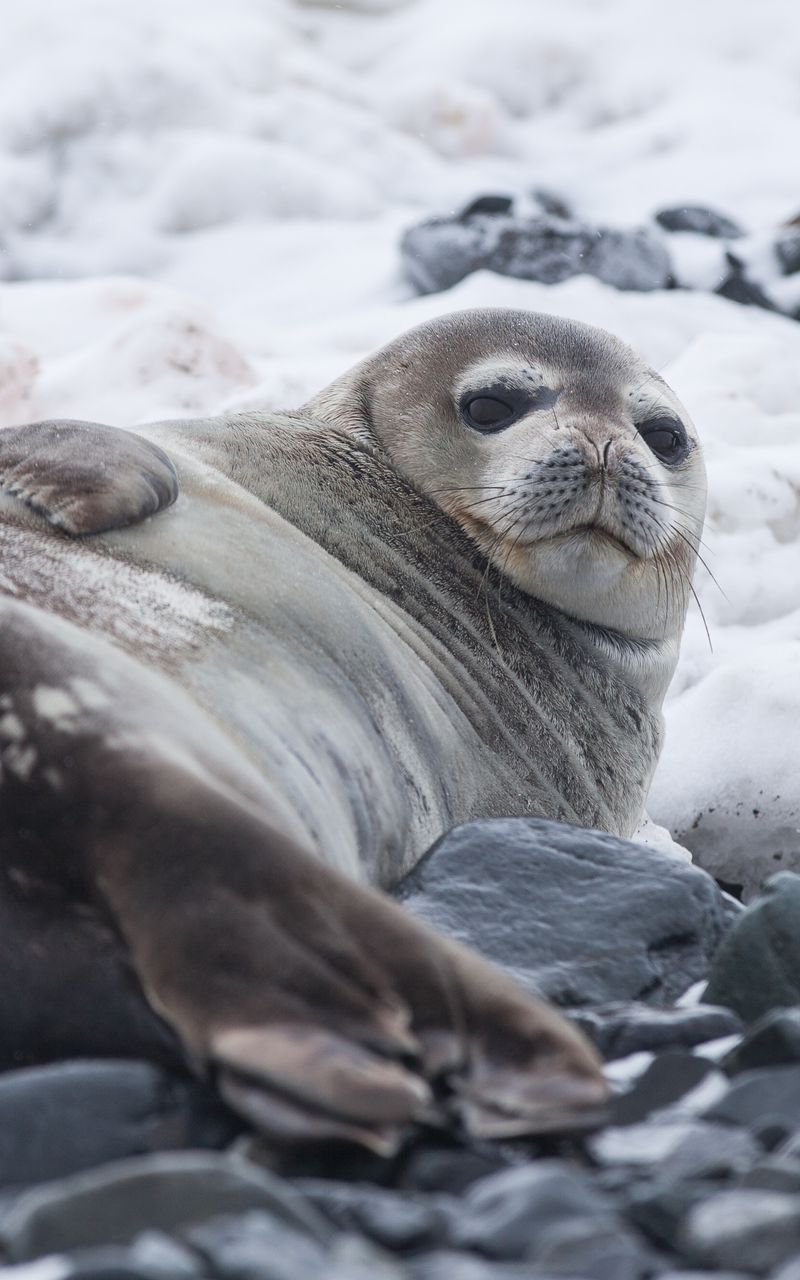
[0,0,800,882]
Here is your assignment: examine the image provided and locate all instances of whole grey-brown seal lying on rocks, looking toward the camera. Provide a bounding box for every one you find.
[0,310,704,1151]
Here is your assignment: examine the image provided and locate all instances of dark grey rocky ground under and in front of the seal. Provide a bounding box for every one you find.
[0,819,800,1280]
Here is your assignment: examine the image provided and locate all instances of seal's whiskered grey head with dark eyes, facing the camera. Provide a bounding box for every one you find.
[306,308,705,640]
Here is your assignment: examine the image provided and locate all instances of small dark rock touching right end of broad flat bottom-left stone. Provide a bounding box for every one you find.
[296,1179,458,1253]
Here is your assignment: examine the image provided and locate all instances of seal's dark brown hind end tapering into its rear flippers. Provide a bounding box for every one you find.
[0,596,607,1153]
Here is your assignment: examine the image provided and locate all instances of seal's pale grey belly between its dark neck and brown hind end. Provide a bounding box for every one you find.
[0,453,642,884]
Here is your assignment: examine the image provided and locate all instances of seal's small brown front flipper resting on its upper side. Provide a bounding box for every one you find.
[0,420,178,538]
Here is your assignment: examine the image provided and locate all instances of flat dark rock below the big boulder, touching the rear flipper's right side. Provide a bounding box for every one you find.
[571,1004,741,1061]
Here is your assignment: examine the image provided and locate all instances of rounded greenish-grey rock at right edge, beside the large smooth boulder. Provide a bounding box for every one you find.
[705,872,800,1023]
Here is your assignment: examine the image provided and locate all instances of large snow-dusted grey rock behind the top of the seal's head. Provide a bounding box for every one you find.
[401,206,671,293]
